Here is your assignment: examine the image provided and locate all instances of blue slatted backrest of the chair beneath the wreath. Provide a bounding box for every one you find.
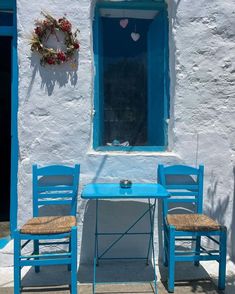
[33,164,80,217]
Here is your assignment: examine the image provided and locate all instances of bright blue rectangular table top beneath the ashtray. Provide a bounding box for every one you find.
[81,183,170,199]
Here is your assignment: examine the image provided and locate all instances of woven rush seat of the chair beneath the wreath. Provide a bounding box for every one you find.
[20,216,76,235]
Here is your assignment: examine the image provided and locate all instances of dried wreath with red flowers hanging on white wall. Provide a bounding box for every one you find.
[31,12,80,65]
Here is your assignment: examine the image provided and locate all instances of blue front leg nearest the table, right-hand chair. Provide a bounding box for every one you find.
[168,226,175,293]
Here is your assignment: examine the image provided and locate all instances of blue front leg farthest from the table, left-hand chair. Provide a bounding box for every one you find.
[14,230,21,294]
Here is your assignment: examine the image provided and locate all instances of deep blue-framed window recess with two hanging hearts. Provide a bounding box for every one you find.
[93,0,169,151]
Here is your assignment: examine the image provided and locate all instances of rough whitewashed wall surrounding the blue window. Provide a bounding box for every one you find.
[0,0,235,268]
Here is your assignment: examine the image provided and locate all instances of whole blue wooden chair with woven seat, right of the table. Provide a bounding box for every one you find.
[158,165,227,292]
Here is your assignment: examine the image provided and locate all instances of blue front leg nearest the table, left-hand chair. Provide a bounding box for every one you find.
[71,227,77,294]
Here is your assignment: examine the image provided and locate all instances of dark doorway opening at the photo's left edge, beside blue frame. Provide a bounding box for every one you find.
[0,36,11,221]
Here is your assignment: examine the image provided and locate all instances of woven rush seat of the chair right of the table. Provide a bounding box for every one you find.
[166,214,221,232]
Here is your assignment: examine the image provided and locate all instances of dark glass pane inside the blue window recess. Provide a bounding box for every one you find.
[101,17,151,146]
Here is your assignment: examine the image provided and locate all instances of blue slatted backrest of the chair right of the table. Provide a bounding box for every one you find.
[158,165,204,217]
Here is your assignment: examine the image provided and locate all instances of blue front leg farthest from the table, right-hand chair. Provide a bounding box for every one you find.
[218,227,227,290]
